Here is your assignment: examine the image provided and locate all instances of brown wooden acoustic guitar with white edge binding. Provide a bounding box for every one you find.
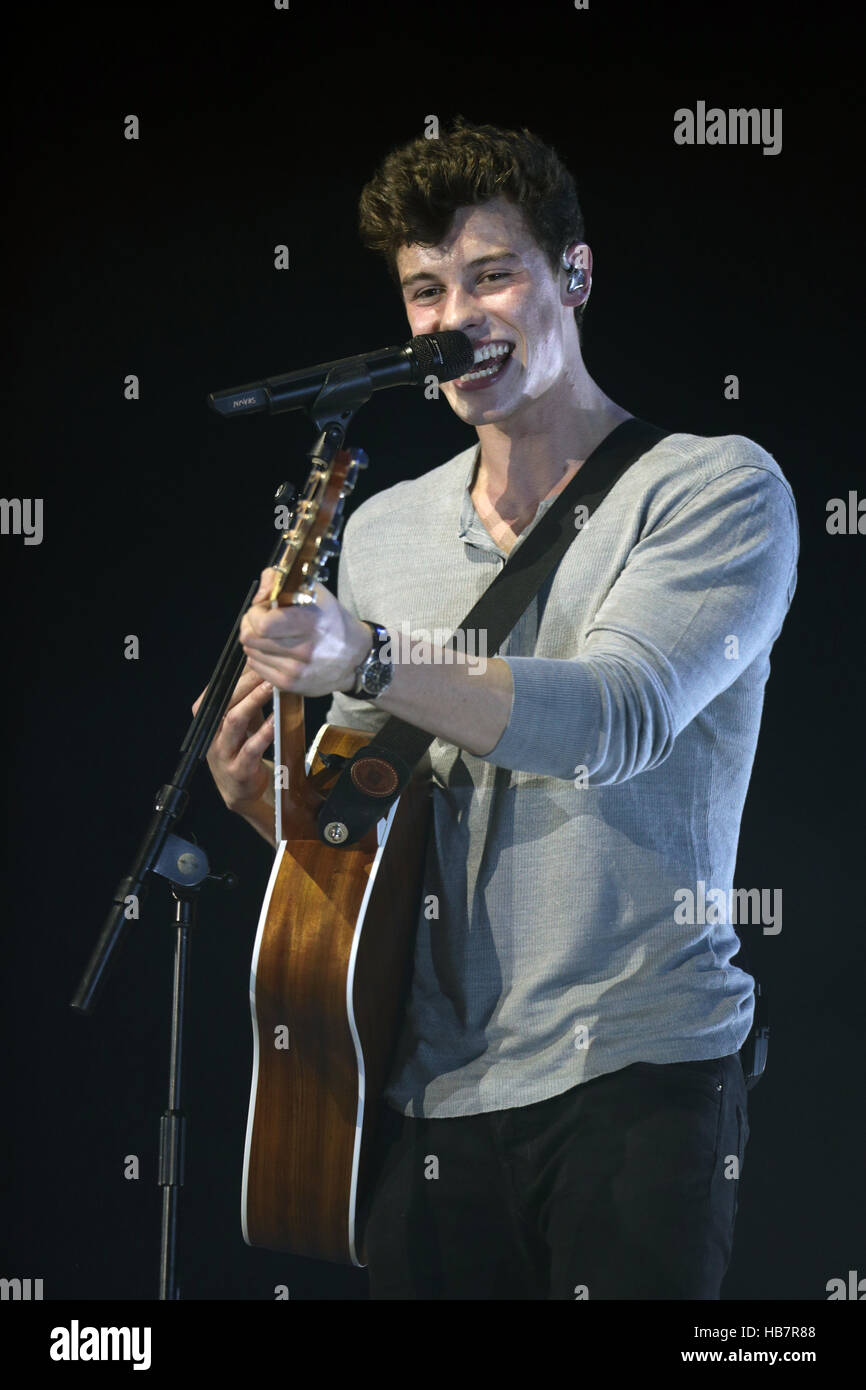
[240,450,430,1266]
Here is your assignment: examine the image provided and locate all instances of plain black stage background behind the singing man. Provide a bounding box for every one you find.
[0,0,866,1300]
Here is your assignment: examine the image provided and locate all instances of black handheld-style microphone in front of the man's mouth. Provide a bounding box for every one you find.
[207,329,475,416]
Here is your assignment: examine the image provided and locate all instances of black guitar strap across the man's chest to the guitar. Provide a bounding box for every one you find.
[318,417,670,847]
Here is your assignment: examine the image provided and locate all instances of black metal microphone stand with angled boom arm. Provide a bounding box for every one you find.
[70,363,373,1301]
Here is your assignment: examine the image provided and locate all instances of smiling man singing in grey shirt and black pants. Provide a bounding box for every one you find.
[195,120,798,1300]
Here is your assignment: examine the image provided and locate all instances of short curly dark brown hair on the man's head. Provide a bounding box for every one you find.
[359,115,584,335]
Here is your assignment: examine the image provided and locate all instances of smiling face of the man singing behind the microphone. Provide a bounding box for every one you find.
[398,197,575,425]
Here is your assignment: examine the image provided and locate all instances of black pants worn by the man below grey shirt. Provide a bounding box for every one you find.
[361,1052,749,1300]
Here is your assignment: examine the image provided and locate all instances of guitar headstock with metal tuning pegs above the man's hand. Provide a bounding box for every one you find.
[270,449,367,607]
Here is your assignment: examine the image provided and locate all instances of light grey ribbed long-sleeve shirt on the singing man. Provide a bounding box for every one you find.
[328,434,798,1116]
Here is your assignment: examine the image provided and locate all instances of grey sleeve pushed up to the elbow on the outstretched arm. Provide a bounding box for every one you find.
[484,467,798,785]
